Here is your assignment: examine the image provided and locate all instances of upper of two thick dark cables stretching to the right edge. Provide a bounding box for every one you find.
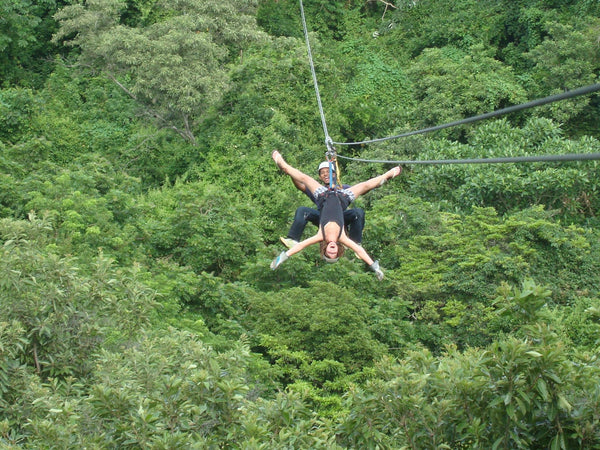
[332,84,600,145]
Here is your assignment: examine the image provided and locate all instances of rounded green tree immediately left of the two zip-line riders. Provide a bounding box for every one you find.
[137,178,260,279]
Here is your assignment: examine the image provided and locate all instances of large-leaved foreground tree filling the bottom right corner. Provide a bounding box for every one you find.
[338,304,599,449]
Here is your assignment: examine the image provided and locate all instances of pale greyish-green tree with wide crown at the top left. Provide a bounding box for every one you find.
[54,0,264,145]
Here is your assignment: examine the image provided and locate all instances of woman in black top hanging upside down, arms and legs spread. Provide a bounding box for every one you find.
[271,150,402,280]
